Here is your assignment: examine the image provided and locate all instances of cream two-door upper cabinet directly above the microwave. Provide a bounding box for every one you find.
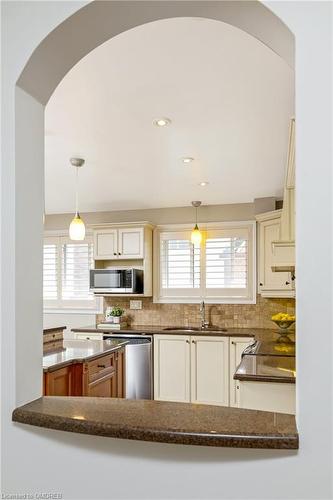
[94,226,145,260]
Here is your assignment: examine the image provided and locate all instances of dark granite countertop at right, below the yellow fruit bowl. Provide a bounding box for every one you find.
[234,355,296,384]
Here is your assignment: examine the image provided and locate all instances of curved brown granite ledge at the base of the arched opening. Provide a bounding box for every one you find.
[12,397,298,449]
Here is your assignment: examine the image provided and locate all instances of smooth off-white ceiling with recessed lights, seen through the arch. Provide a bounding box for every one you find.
[45,18,294,213]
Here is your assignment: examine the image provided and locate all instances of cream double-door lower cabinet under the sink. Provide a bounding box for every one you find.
[154,335,229,406]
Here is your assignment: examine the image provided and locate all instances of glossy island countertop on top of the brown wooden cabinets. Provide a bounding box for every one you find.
[43,339,128,372]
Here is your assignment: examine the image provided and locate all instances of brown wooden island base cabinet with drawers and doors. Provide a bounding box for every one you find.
[44,349,125,398]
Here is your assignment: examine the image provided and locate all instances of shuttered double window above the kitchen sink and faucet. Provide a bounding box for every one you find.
[154,222,256,303]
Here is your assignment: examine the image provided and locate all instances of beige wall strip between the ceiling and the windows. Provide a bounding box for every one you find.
[44,198,275,231]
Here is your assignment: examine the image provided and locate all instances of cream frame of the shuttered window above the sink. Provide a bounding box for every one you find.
[153,221,257,304]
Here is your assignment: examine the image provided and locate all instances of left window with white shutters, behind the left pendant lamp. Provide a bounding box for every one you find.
[43,236,97,310]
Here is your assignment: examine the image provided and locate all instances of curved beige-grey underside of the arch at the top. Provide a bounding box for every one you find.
[17,0,294,104]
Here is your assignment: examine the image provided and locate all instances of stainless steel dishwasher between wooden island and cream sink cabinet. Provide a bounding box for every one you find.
[103,332,153,399]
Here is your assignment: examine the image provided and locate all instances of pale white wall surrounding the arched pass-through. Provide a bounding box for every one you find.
[1,2,332,499]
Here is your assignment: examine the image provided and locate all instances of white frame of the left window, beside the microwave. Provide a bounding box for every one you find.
[43,231,103,314]
